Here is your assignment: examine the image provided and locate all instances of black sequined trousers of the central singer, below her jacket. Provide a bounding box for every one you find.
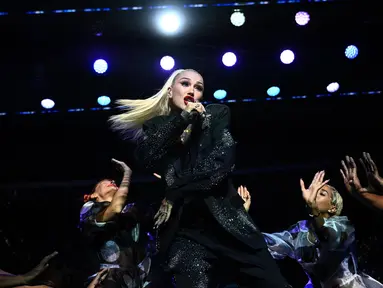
[168,236,288,288]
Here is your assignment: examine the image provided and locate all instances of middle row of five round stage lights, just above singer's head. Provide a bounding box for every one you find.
[93,45,359,74]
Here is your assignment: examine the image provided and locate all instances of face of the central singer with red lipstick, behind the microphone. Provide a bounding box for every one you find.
[169,70,204,110]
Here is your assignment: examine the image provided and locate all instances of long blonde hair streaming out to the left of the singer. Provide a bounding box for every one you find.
[109,69,190,140]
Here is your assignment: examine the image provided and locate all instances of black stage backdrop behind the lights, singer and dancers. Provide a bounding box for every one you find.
[0,1,383,287]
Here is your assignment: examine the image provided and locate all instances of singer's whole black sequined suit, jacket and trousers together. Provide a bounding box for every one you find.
[137,104,287,288]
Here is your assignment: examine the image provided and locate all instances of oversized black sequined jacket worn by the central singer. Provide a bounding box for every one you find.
[137,104,267,249]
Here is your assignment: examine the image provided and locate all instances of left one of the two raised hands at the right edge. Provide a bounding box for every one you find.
[340,156,368,194]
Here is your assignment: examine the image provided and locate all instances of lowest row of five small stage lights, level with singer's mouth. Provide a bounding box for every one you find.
[41,82,340,109]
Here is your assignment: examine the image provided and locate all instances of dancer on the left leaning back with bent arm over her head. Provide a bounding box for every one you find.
[80,159,154,288]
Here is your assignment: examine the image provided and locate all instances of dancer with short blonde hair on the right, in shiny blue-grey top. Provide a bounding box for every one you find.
[249,171,383,288]
